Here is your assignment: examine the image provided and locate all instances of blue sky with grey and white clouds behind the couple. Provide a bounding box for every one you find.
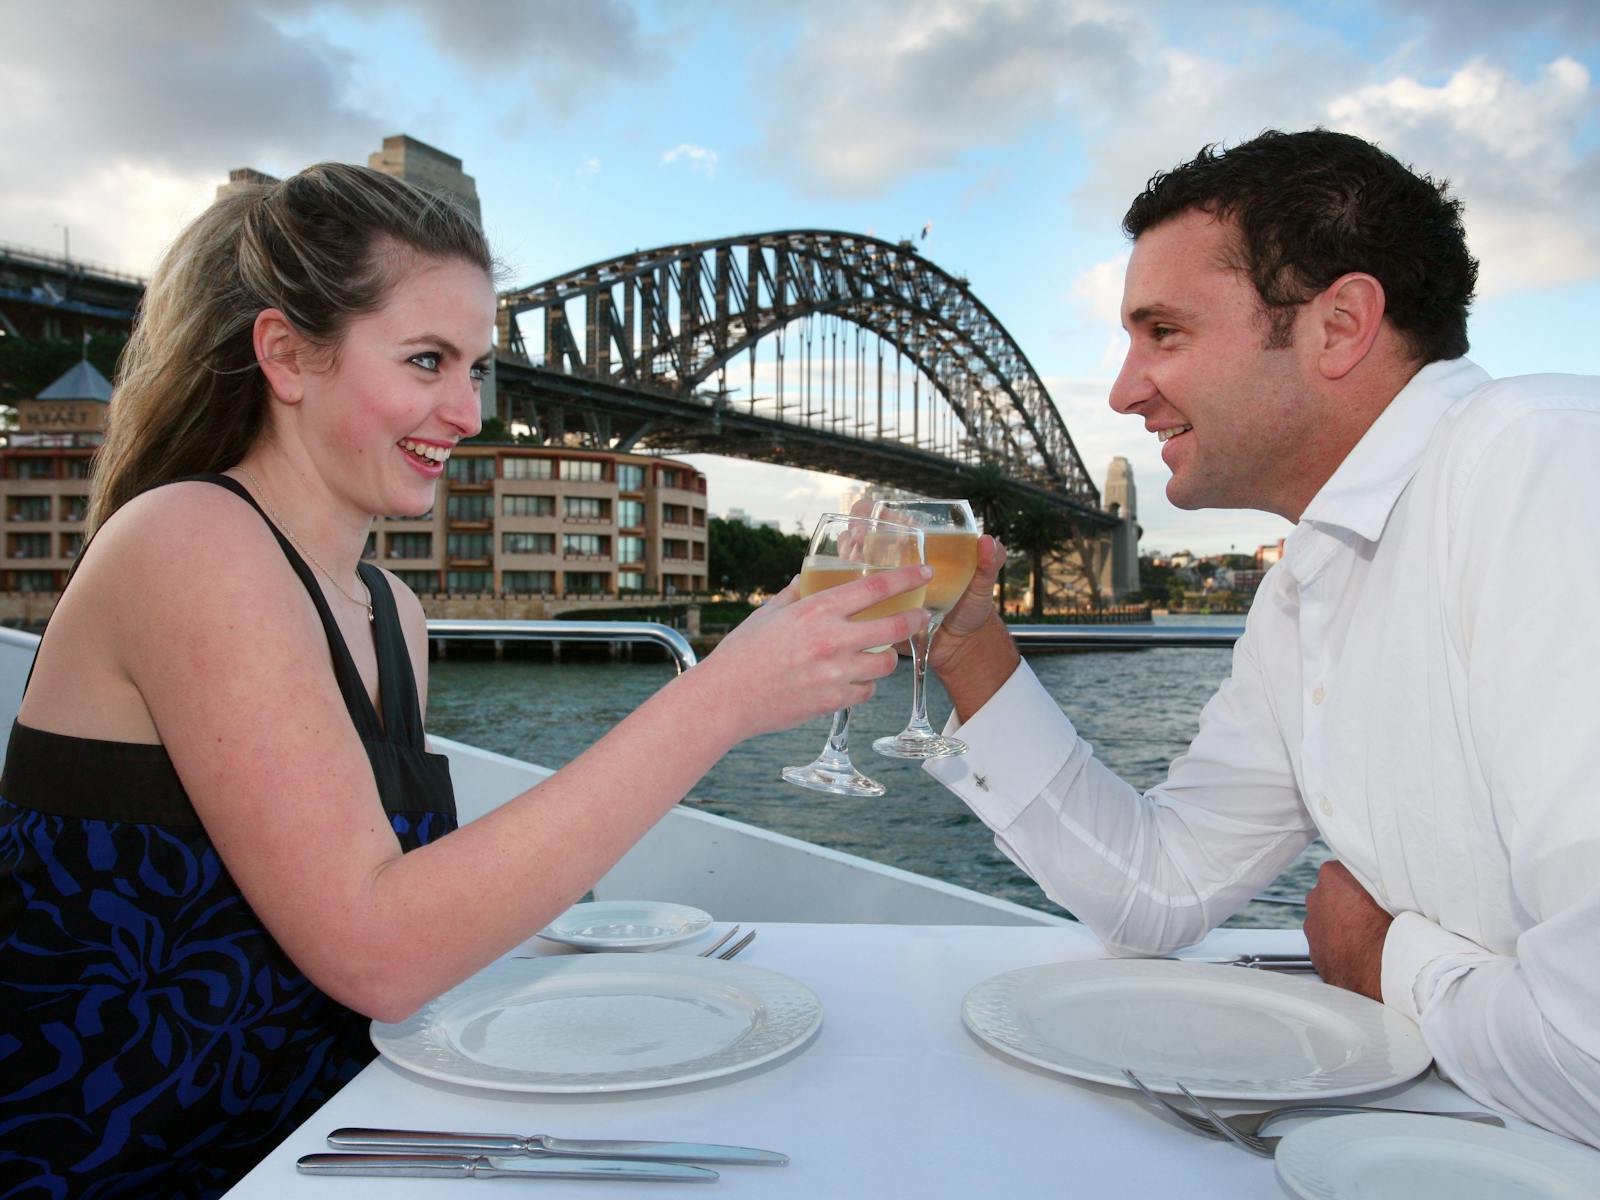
[0,0,1600,554]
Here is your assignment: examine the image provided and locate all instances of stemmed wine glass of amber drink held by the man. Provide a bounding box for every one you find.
[872,499,979,758]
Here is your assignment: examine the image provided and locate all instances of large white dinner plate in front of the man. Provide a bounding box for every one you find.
[962,958,1432,1101]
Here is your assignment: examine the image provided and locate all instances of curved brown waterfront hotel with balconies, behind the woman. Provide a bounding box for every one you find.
[0,362,707,601]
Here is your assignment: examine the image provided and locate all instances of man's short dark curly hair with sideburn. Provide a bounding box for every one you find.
[1122,130,1478,363]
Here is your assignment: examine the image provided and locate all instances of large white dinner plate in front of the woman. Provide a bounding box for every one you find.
[373,954,822,1091]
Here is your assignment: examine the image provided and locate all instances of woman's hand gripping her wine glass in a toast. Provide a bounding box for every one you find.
[694,565,933,741]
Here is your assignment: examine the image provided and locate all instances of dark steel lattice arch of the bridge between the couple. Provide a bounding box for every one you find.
[498,229,1112,525]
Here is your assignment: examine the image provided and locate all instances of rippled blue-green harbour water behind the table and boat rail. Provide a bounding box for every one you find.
[427,616,1328,926]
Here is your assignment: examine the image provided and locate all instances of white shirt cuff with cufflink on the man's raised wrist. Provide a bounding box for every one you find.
[922,661,1078,832]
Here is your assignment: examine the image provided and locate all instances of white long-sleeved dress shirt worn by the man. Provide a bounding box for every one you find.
[926,358,1600,1146]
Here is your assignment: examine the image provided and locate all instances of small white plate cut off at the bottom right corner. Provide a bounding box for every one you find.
[1277,1112,1600,1200]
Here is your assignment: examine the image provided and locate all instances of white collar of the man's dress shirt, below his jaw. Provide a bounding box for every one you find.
[1301,358,1490,541]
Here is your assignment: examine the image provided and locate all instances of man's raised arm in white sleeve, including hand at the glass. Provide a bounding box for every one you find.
[925,539,1312,954]
